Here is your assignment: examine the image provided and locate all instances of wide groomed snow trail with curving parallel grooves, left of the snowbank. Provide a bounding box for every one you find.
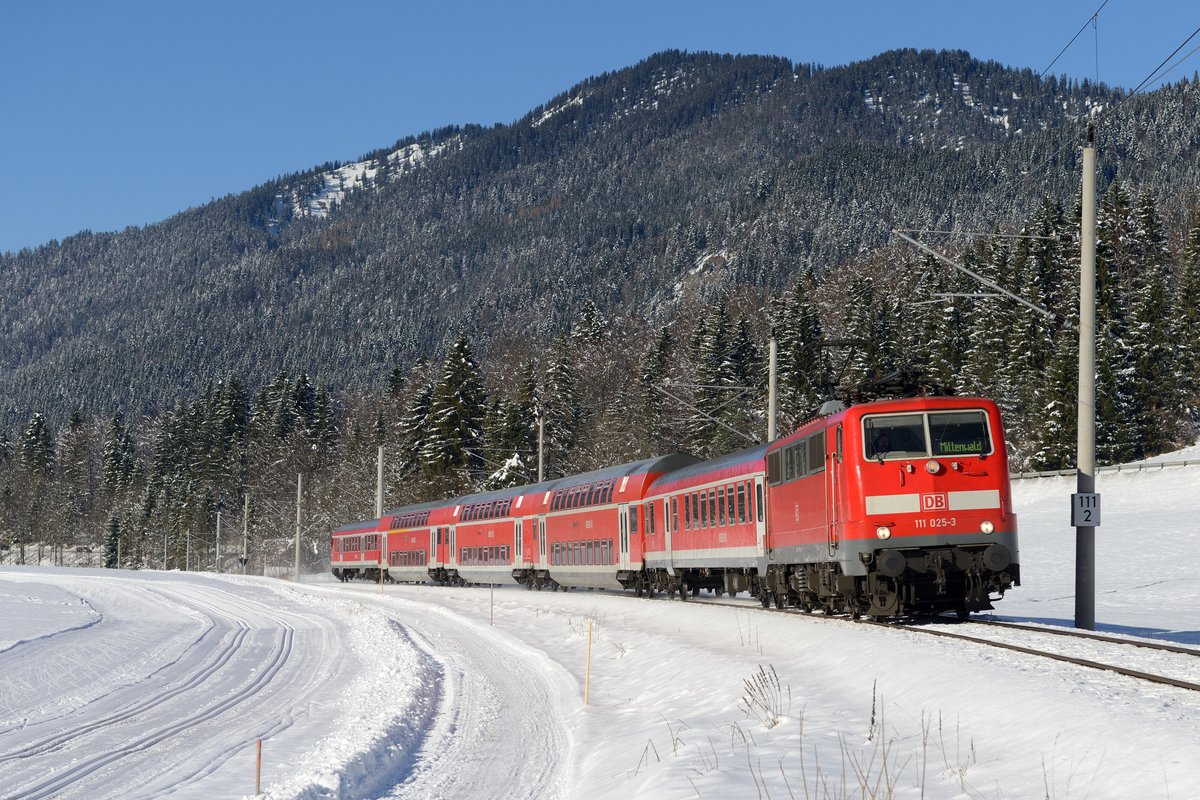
[0,573,343,799]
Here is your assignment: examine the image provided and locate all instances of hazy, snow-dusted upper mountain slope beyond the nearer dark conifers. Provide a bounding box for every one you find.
[0,50,1180,420]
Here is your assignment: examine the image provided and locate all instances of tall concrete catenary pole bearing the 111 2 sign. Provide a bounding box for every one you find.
[1075,126,1096,631]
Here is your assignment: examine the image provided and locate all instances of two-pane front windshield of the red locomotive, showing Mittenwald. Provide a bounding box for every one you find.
[863,411,991,461]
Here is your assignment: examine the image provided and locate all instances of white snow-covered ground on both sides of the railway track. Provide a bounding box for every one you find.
[0,449,1200,800]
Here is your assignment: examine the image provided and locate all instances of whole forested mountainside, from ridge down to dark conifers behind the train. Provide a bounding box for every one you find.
[0,50,1200,568]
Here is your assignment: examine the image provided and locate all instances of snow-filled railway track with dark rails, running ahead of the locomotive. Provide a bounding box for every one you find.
[690,599,1200,692]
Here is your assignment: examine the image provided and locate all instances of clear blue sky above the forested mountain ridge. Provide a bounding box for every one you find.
[0,0,1200,251]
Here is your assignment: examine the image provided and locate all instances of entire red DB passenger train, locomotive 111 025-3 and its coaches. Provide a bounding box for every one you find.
[331,397,1020,618]
